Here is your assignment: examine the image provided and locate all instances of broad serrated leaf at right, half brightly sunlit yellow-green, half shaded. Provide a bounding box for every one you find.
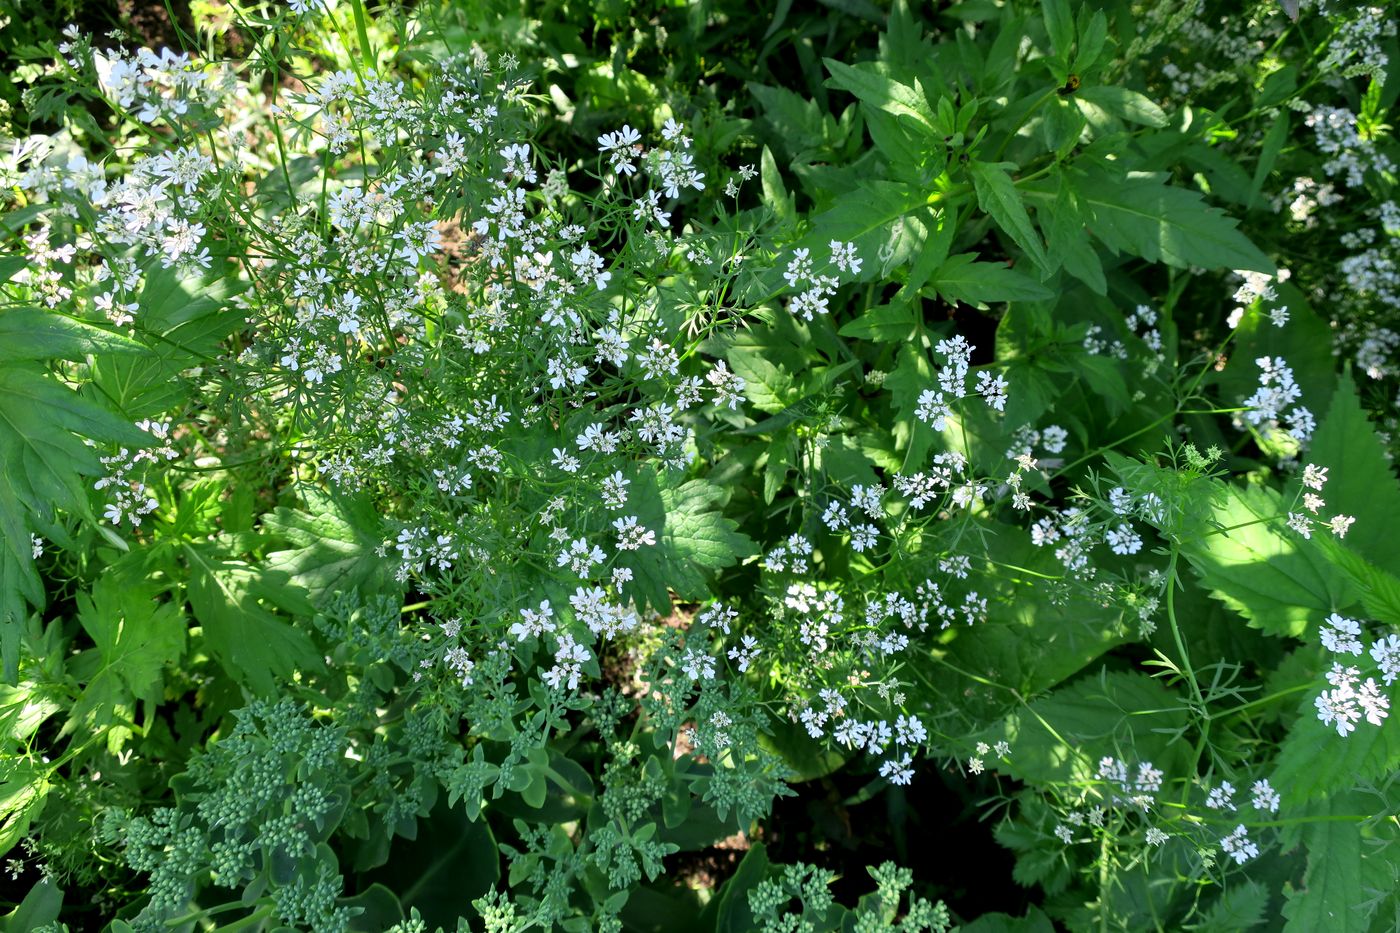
[1182,481,1355,637]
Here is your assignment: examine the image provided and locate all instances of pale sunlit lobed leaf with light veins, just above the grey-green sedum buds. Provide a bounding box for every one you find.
[262,486,396,602]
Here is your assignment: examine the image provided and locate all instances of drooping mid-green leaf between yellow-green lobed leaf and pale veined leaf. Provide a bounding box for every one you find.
[181,544,322,696]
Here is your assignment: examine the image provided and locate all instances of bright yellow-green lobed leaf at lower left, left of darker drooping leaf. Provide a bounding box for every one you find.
[63,573,188,754]
